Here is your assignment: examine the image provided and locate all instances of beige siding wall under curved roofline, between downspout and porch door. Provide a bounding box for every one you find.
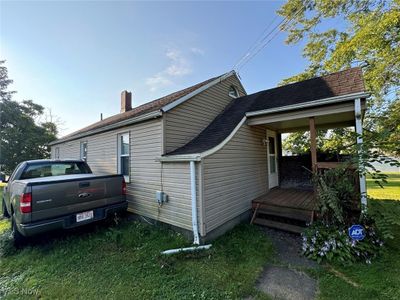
[203,124,268,232]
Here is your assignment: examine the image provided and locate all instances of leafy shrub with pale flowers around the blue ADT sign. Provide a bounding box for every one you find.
[302,168,383,264]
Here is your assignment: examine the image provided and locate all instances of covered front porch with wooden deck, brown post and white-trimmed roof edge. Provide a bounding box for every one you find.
[247,98,366,233]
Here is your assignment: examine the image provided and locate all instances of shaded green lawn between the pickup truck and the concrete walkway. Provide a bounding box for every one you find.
[0,198,272,299]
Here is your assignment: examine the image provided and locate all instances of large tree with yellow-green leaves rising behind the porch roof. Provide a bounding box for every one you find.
[278,0,400,155]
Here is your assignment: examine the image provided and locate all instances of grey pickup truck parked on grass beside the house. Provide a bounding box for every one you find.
[2,160,128,244]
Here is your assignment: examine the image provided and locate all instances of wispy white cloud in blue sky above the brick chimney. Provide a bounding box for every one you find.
[146,48,192,92]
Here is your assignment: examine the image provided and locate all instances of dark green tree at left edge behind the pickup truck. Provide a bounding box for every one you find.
[0,61,57,174]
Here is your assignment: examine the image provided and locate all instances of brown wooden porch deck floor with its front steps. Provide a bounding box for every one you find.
[251,188,315,233]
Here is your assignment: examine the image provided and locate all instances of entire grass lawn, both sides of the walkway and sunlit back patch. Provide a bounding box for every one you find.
[0,174,400,300]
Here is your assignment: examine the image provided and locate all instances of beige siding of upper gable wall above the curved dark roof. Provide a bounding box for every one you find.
[164,75,245,152]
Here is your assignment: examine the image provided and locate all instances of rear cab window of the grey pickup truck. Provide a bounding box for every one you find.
[21,162,91,179]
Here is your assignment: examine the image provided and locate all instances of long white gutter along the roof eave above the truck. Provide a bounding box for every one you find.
[49,110,162,146]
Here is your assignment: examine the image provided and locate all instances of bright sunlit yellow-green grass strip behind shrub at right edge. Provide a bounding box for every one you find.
[367,173,400,200]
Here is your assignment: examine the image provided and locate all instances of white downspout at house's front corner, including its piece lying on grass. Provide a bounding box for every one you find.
[161,160,212,255]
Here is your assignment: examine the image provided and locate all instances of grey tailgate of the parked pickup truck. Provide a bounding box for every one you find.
[30,175,125,221]
